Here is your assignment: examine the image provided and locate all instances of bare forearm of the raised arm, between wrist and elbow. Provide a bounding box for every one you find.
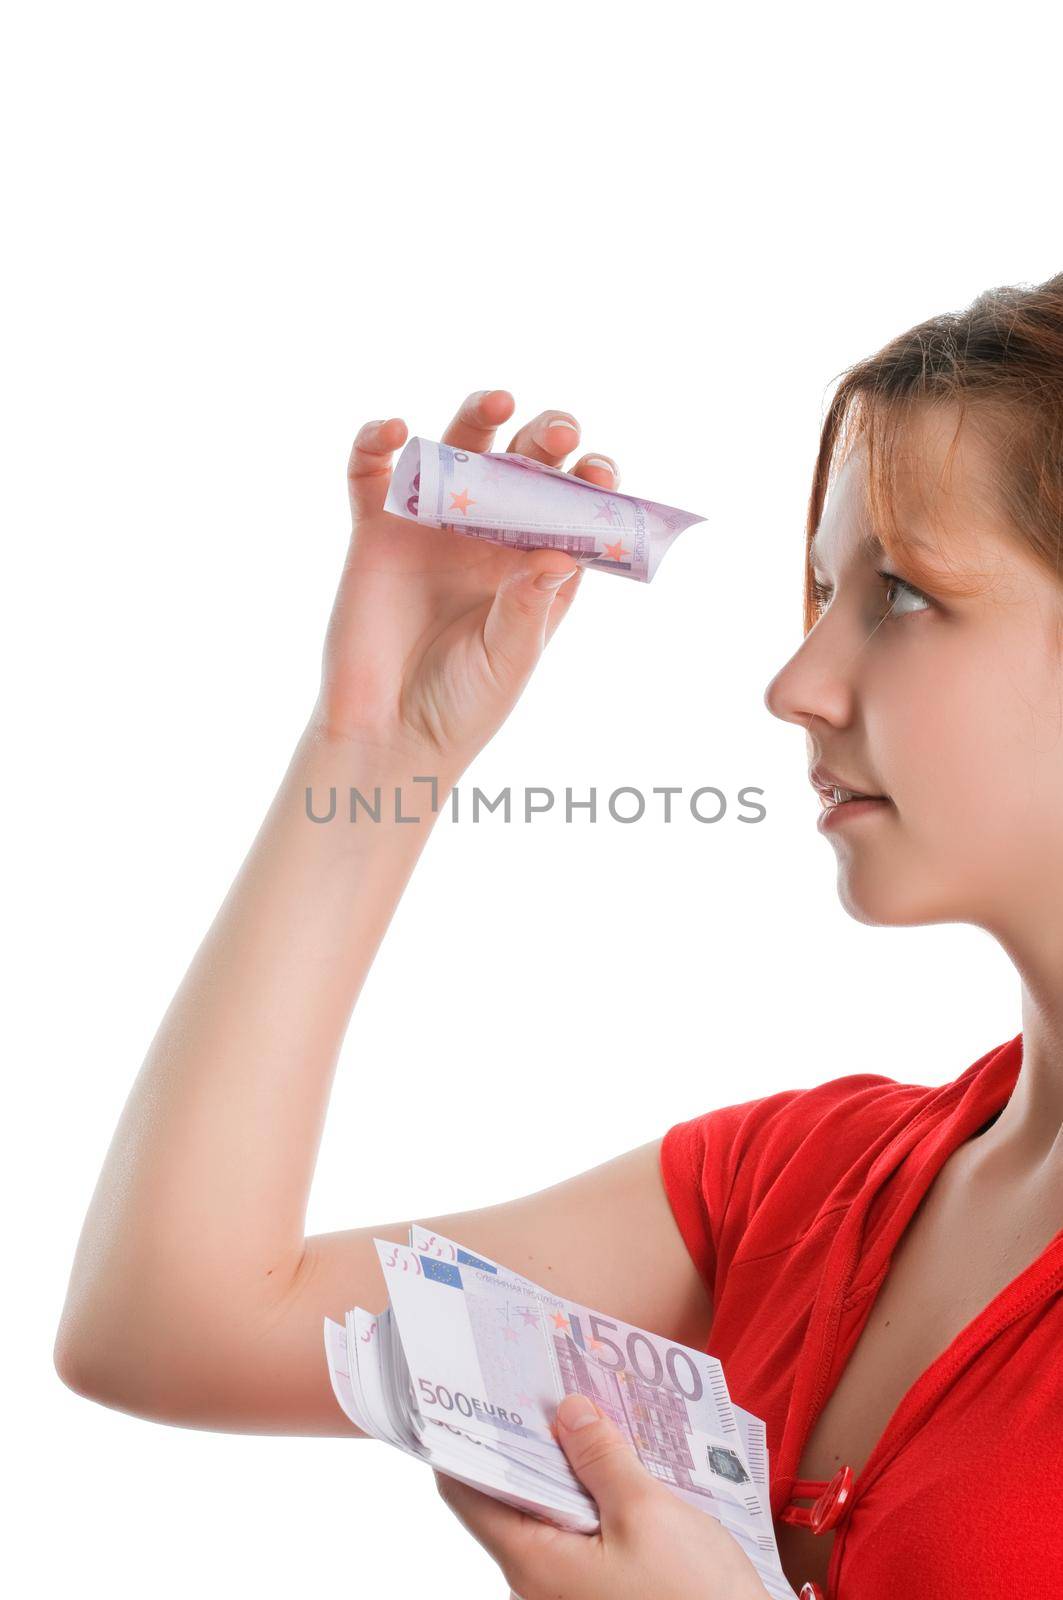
[56,725,453,1370]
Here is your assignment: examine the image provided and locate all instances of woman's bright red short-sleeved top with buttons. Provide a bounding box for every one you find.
[661,1034,1063,1600]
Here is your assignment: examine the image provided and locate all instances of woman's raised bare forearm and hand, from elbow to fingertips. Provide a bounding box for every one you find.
[54,390,653,1429]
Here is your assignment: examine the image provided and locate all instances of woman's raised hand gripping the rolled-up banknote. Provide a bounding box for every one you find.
[314,389,618,776]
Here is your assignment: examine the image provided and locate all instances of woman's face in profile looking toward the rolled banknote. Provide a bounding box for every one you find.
[764,408,1063,942]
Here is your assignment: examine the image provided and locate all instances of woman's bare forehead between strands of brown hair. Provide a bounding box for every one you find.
[808,406,1015,570]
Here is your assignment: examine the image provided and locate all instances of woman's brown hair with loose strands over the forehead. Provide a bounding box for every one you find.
[804,272,1063,634]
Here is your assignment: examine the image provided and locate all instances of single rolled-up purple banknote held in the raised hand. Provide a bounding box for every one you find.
[384,438,704,584]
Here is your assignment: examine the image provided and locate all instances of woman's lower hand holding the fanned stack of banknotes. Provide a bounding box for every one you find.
[435,1395,767,1600]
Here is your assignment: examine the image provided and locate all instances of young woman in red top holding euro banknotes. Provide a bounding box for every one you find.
[56,274,1063,1600]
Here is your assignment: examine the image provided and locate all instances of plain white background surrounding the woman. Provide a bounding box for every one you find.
[0,0,1060,1600]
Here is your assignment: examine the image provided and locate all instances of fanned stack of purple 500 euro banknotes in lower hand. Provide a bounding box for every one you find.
[325,1226,796,1600]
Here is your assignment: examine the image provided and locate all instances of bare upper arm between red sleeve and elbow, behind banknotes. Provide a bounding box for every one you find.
[135,1139,712,1437]
